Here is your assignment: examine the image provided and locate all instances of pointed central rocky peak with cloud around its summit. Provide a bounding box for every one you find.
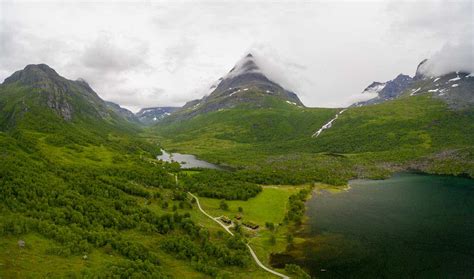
[169,53,304,119]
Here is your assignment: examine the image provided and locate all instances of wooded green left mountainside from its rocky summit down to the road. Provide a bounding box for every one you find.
[0,65,266,278]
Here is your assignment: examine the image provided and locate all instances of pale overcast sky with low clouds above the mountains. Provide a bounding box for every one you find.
[0,0,474,111]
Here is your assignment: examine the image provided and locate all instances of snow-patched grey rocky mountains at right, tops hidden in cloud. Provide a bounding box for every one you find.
[352,59,474,109]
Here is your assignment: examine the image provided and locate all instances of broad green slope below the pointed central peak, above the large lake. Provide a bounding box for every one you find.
[154,94,474,185]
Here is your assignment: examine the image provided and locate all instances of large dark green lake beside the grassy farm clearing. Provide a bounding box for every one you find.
[280,174,474,278]
